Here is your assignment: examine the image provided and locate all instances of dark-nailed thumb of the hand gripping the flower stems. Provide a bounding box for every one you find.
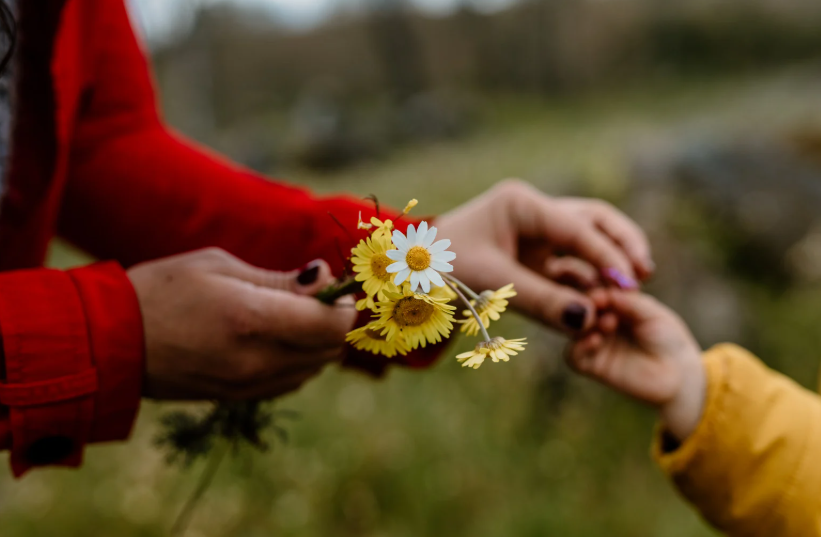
[221,259,334,296]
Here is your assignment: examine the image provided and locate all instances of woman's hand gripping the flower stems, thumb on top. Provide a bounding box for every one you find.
[128,249,356,399]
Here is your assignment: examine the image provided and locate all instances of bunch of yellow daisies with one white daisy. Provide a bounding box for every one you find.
[340,200,526,369]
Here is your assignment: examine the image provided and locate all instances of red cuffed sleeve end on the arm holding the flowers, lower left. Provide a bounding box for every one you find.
[0,263,143,476]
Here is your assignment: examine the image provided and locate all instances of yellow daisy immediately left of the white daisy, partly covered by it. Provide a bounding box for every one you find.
[351,234,399,311]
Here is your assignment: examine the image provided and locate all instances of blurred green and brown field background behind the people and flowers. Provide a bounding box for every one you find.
[8,0,821,537]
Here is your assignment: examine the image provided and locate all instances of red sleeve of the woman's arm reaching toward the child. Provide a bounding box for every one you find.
[54,1,438,374]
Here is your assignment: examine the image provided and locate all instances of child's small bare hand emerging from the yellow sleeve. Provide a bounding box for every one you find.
[568,289,706,441]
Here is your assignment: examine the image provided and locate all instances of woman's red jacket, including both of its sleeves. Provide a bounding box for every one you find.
[0,0,437,475]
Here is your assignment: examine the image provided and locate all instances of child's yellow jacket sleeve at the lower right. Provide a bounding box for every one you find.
[653,345,821,537]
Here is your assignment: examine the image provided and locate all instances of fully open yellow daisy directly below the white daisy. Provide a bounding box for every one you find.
[374,286,456,349]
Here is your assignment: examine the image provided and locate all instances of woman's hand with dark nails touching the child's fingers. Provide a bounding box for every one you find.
[436,180,653,333]
